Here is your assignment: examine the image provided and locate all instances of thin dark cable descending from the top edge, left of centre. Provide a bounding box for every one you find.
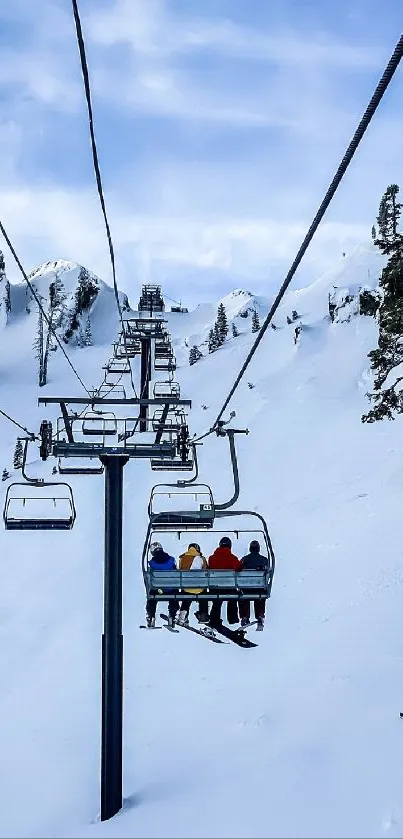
[72,0,137,398]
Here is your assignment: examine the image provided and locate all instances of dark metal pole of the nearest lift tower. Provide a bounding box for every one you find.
[100,455,129,821]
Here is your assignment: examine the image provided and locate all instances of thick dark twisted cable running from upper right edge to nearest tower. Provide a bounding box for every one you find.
[196,35,403,442]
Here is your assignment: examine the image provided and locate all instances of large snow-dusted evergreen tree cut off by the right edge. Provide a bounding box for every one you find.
[361,184,403,422]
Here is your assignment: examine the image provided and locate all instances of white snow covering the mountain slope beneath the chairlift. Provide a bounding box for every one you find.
[0,248,403,839]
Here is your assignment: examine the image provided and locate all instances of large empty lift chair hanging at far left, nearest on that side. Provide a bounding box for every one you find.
[3,481,76,530]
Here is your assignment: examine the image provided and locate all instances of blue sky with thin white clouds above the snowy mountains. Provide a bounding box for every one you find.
[0,0,403,304]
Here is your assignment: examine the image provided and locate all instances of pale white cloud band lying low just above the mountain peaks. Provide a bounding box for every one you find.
[2,188,367,301]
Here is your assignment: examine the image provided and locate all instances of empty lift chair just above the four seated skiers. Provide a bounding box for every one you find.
[148,484,214,530]
